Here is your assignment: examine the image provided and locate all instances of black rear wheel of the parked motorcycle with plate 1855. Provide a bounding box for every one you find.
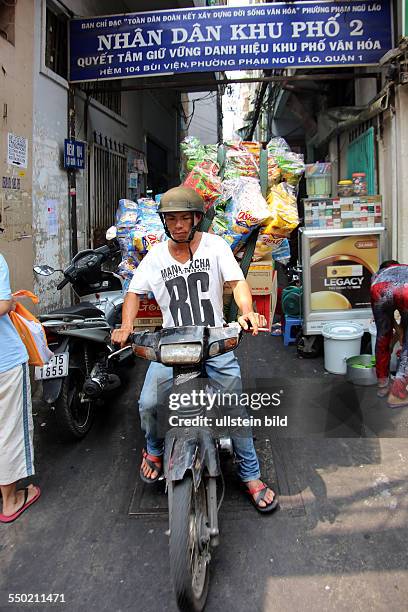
[55,368,95,441]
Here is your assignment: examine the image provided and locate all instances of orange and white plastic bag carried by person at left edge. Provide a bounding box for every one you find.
[9,290,53,366]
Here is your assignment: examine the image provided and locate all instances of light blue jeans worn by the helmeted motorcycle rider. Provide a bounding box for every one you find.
[139,353,260,482]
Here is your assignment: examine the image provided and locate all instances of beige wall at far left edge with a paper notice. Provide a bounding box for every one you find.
[0,0,34,290]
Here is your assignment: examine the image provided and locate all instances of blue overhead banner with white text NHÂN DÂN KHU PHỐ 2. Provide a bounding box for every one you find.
[70,0,393,82]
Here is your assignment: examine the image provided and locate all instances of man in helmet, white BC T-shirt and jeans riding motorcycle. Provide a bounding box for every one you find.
[112,186,278,512]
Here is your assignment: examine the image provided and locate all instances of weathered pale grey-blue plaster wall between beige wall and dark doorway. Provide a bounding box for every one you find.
[33,2,77,308]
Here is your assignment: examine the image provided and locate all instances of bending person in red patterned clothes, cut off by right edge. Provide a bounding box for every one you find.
[371,260,408,408]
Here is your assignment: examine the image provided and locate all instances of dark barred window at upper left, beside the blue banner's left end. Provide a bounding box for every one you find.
[45,4,68,79]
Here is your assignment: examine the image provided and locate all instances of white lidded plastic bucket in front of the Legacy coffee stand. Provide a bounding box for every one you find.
[322,321,364,374]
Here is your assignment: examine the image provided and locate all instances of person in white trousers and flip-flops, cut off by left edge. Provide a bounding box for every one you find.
[0,254,41,523]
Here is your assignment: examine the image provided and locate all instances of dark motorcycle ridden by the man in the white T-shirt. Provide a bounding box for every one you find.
[130,323,242,612]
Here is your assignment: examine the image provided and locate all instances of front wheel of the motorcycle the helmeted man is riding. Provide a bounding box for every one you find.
[169,476,210,612]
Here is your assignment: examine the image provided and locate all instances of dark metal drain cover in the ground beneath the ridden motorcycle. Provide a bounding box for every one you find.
[129,438,306,518]
